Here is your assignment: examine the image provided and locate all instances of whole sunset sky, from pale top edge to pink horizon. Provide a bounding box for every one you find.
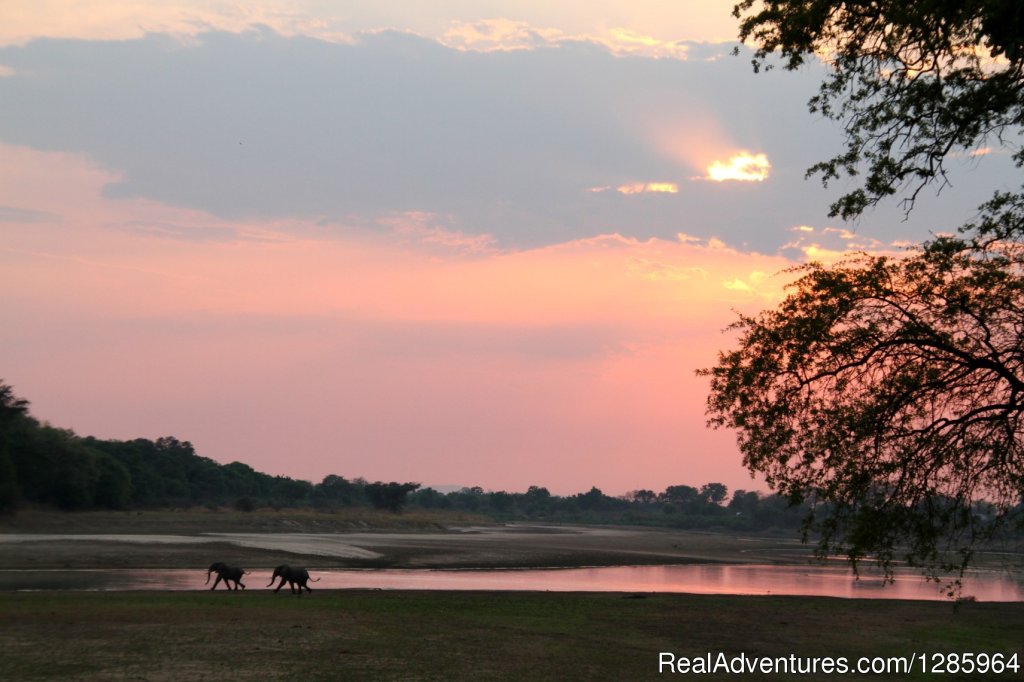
[0,0,1011,495]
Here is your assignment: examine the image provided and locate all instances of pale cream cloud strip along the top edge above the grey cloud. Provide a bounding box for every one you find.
[0,0,749,51]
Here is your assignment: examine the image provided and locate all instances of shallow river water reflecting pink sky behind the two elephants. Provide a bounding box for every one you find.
[0,564,1024,601]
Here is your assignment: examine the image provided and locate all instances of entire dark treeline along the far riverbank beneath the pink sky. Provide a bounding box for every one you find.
[0,382,806,529]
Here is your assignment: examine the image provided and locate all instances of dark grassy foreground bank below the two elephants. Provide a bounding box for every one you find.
[0,590,1024,681]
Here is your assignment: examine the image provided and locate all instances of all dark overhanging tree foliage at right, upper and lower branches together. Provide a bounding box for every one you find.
[716,0,1024,576]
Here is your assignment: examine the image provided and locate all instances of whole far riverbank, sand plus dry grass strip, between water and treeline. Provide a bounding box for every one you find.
[0,510,810,570]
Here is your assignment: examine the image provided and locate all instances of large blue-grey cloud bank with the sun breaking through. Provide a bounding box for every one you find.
[0,24,1007,252]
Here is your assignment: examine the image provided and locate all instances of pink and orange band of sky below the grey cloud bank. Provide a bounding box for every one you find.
[0,146,790,494]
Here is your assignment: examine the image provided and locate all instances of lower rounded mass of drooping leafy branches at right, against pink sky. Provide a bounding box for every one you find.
[700,223,1024,574]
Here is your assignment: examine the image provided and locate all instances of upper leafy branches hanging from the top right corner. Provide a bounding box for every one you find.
[733,0,1024,218]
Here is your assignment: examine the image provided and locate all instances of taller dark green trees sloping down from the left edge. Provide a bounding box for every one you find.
[0,382,419,511]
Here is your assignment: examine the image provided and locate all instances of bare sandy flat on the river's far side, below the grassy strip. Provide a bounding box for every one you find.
[0,524,812,569]
